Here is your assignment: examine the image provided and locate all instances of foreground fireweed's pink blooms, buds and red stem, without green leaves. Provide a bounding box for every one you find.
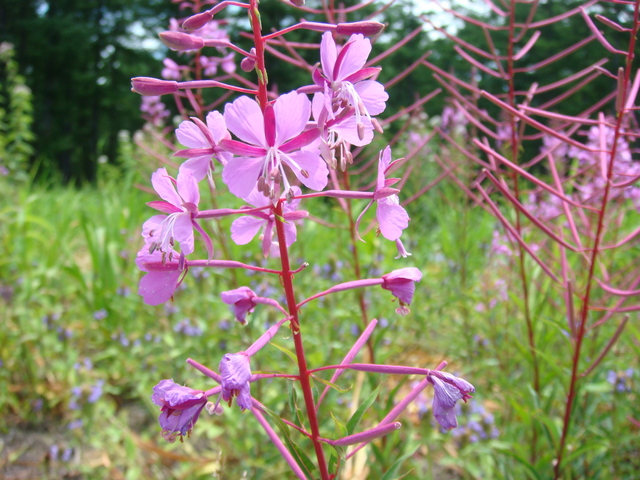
[132,0,474,480]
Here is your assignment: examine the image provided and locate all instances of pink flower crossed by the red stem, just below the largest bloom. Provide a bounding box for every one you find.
[231,187,309,258]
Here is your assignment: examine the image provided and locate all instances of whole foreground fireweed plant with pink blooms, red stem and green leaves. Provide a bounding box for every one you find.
[132,0,474,480]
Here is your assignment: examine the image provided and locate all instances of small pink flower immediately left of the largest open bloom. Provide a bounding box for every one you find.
[176,111,231,182]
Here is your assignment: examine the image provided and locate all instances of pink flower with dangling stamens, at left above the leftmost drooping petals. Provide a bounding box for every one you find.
[142,168,213,257]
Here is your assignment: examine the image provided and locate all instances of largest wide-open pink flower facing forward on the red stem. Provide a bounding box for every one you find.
[221,92,329,199]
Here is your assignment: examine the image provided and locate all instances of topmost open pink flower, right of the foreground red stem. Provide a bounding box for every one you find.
[313,32,389,129]
